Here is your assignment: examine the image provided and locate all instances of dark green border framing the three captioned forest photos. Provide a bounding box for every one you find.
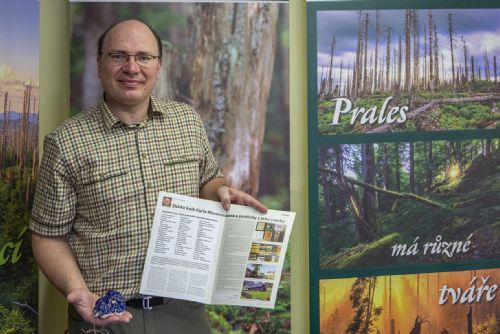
[306,0,500,333]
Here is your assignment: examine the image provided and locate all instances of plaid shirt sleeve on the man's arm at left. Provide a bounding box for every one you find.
[30,135,76,236]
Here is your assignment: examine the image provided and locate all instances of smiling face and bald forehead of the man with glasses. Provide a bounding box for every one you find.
[97,20,161,109]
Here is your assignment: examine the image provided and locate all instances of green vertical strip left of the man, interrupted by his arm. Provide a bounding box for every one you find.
[38,0,69,334]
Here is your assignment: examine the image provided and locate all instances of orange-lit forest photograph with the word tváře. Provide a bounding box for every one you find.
[319,269,500,334]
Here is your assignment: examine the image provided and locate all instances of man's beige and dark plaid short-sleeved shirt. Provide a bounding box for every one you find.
[30,97,222,298]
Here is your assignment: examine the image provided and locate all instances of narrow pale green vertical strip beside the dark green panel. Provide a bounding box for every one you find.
[289,0,309,334]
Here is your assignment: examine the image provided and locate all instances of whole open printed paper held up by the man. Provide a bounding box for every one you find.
[140,192,295,308]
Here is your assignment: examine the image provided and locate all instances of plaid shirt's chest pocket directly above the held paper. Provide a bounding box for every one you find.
[163,155,200,197]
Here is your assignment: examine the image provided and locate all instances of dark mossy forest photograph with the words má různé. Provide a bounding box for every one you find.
[317,138,500,270]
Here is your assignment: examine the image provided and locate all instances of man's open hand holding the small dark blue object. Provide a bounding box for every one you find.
[67,290,132,326]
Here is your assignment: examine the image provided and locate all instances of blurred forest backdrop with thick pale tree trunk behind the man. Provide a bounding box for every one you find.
[70,2,291,333]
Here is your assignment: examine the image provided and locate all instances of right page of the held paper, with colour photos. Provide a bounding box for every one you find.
[212,204,295,308]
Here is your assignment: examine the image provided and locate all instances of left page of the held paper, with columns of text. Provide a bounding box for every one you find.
[140,192,225,303]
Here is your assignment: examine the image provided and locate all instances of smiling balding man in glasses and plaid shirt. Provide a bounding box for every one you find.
[30,20,267,333]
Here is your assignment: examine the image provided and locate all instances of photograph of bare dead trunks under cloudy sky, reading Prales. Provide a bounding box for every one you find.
[315,8,500,135]
